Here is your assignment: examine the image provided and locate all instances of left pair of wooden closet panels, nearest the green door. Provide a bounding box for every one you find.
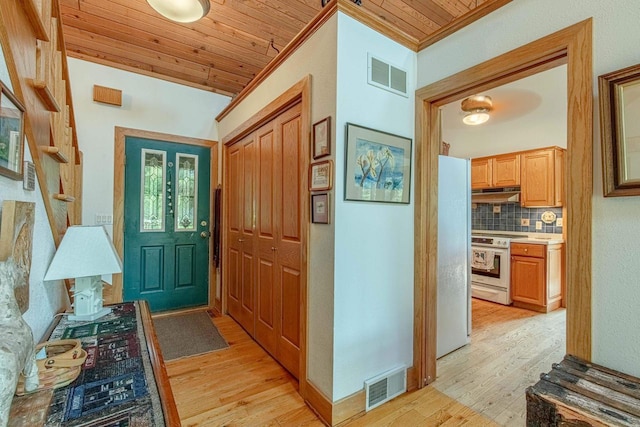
[227,135,256,335]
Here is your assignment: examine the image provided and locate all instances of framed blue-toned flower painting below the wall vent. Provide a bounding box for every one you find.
[344,123,412,203]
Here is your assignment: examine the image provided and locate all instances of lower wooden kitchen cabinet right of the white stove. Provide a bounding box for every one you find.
[511,242,564,313]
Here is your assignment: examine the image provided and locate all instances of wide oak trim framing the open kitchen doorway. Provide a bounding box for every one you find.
[410,19,593,387]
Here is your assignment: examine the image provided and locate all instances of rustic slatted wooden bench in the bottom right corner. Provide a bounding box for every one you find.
[526,355,640,426]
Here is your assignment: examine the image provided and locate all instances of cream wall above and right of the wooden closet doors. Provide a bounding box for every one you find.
[218,16,342,398]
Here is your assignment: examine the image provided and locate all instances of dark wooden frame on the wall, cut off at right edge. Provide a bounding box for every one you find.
[598,64,640,197]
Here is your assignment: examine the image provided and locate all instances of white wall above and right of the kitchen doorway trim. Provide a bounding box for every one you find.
[418,0,640,376]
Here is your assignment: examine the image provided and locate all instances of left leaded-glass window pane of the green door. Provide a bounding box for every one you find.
[140,149,167,231]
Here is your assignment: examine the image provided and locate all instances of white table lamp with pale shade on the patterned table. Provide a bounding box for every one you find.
[44,225,122,320]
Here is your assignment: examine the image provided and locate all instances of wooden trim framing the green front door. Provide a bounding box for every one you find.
[111,126,218,309]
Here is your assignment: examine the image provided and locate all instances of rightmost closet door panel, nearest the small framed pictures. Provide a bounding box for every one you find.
[275,104,304,378]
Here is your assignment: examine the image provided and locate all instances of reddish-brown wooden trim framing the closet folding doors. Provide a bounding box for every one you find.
[221,75,311,399]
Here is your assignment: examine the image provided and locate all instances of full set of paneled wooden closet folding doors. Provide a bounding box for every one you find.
[223,103,306,378]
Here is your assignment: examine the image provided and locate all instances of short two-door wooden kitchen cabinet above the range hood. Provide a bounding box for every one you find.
[471,153,520,190]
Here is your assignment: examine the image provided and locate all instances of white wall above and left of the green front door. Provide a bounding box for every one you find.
[68,58,230,236]
